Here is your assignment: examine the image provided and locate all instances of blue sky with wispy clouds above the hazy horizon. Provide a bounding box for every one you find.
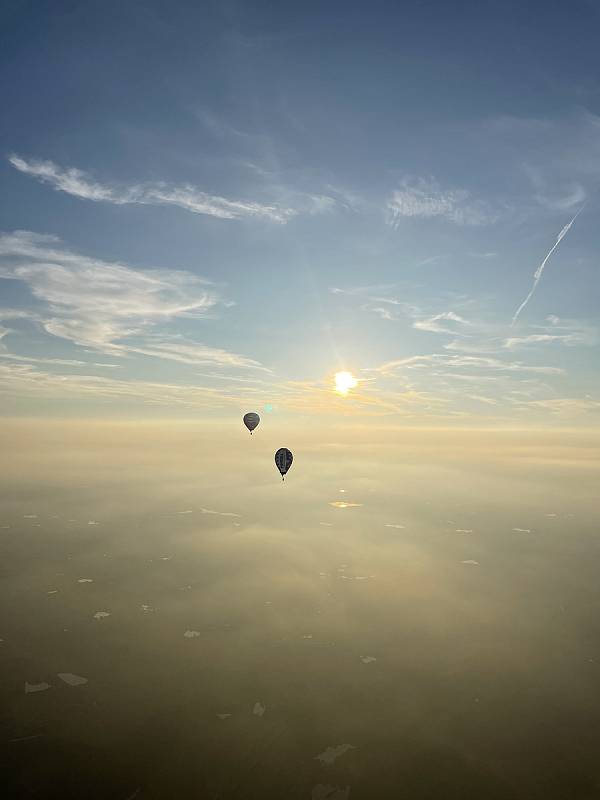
[0,0,600,425]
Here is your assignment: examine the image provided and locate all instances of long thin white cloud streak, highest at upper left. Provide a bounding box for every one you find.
[8,154,298,223]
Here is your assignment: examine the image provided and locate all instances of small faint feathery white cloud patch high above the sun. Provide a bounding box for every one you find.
[387,178,495,228]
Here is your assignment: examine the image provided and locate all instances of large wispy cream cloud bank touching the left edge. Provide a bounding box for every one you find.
[0,231,262,368]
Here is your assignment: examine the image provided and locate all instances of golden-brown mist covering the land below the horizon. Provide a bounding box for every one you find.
[0,417,600,800]
